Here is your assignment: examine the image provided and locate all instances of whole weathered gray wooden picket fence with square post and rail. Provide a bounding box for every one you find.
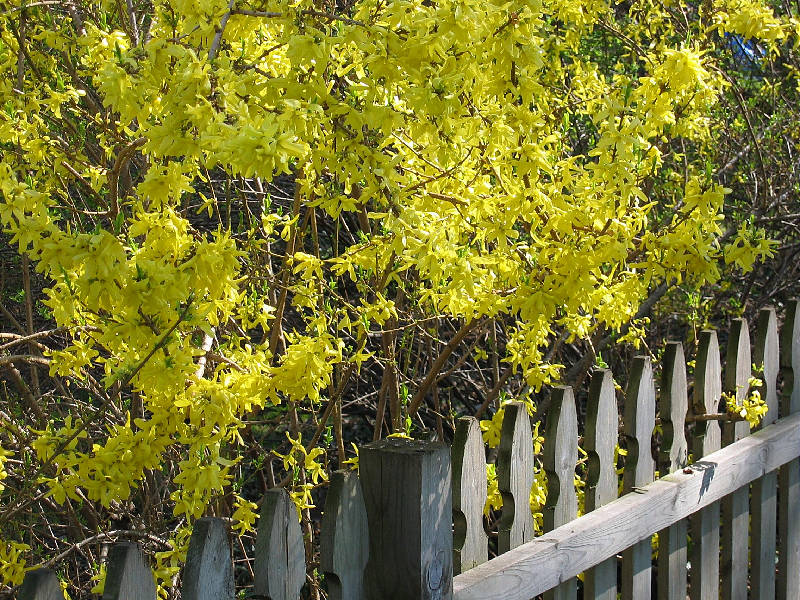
[18,301,800,600]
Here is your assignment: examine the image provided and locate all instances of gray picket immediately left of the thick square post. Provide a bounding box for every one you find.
[320,471,369,600]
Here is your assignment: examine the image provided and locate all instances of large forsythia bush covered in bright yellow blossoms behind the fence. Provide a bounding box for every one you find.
[0,0,798,593]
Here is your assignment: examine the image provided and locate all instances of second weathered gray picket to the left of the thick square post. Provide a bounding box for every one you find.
[253,488,306,600]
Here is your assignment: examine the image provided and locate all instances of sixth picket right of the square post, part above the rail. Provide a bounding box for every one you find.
[658,342,689,475]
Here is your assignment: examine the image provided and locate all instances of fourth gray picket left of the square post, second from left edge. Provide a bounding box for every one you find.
[103,542,156,600]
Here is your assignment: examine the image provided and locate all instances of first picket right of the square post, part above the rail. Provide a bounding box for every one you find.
[452,417,489,574]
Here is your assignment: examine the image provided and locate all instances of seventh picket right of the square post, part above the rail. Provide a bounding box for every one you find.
[692,329,722,460]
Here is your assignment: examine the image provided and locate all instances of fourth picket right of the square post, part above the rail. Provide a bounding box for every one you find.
[584,369,618,510]
